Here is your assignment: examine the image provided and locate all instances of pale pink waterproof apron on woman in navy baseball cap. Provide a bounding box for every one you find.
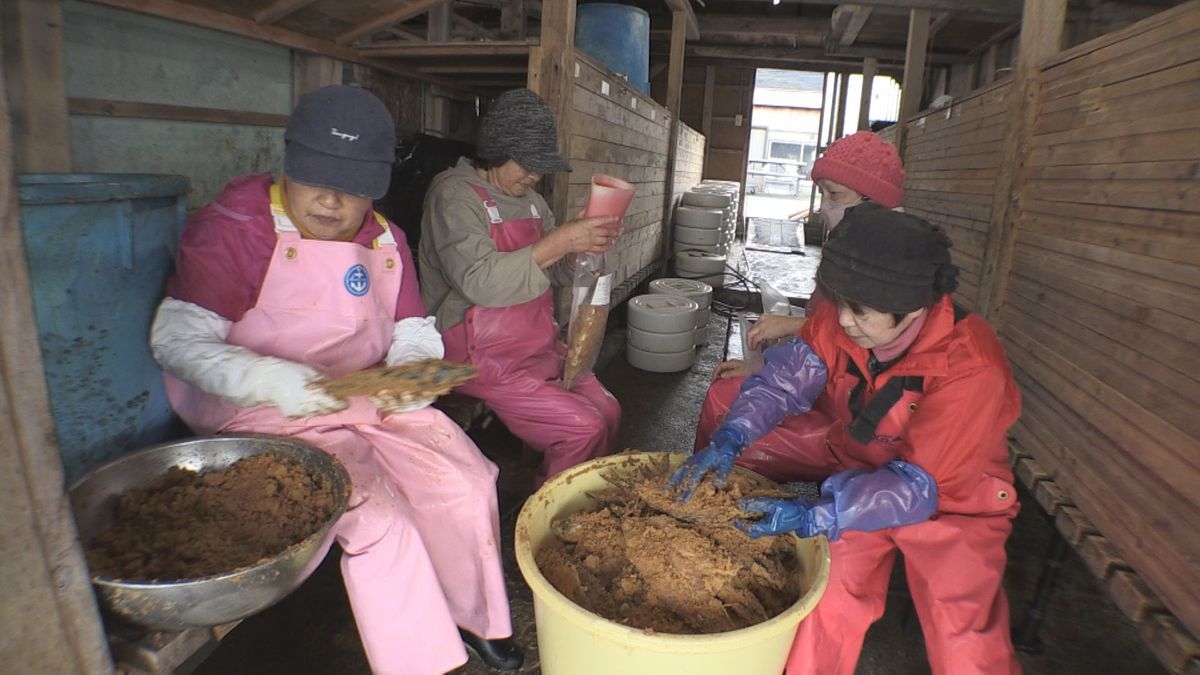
[167,185,512,675]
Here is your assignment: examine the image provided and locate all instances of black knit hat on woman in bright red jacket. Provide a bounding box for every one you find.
[817,202,959,313]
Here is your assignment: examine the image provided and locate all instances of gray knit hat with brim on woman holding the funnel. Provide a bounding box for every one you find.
[475,89,571,174]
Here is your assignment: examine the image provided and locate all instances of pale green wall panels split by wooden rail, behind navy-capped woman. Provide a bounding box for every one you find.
[64,1,292,208]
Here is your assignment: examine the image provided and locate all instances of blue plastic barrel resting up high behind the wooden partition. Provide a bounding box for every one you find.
[575,2,650,94]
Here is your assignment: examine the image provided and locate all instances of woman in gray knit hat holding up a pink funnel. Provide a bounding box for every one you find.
[420,89,620,485]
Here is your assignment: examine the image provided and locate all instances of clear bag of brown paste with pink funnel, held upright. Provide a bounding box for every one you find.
[563,174,637,389]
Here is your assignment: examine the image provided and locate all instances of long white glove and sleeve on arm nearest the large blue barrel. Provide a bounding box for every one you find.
[150,298,346,418]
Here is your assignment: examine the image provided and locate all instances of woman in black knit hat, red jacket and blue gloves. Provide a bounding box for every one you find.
[672,204,1020,675]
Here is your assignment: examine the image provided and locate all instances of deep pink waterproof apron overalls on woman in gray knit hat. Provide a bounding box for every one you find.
[443,185,620,485]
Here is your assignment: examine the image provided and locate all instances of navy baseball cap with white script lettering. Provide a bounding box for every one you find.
[283,84,396,199]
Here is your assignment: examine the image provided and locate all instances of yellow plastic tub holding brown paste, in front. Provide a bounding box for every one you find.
[516,453,829,675]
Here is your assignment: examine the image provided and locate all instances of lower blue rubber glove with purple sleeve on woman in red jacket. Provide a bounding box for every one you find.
[734,460,937,540]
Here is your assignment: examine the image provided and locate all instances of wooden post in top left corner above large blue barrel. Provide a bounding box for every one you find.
[0,0,71,173]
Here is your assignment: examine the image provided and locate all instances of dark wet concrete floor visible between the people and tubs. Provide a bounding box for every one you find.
[187,246,1165,675]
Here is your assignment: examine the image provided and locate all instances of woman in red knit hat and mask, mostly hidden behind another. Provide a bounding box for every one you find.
[696,131,904,468]
